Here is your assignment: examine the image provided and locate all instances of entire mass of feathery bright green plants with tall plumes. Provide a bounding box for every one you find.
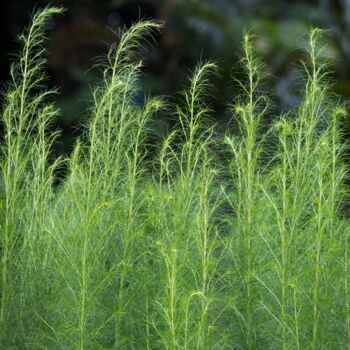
[0,8,350,350]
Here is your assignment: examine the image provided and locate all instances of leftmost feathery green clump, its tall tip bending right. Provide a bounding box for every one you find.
[0,8,61,348]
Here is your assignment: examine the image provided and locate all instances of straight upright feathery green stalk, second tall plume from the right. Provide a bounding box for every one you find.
[226,35,267,349]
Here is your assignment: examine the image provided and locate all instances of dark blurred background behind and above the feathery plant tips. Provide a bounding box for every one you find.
[0,0,350,152]
